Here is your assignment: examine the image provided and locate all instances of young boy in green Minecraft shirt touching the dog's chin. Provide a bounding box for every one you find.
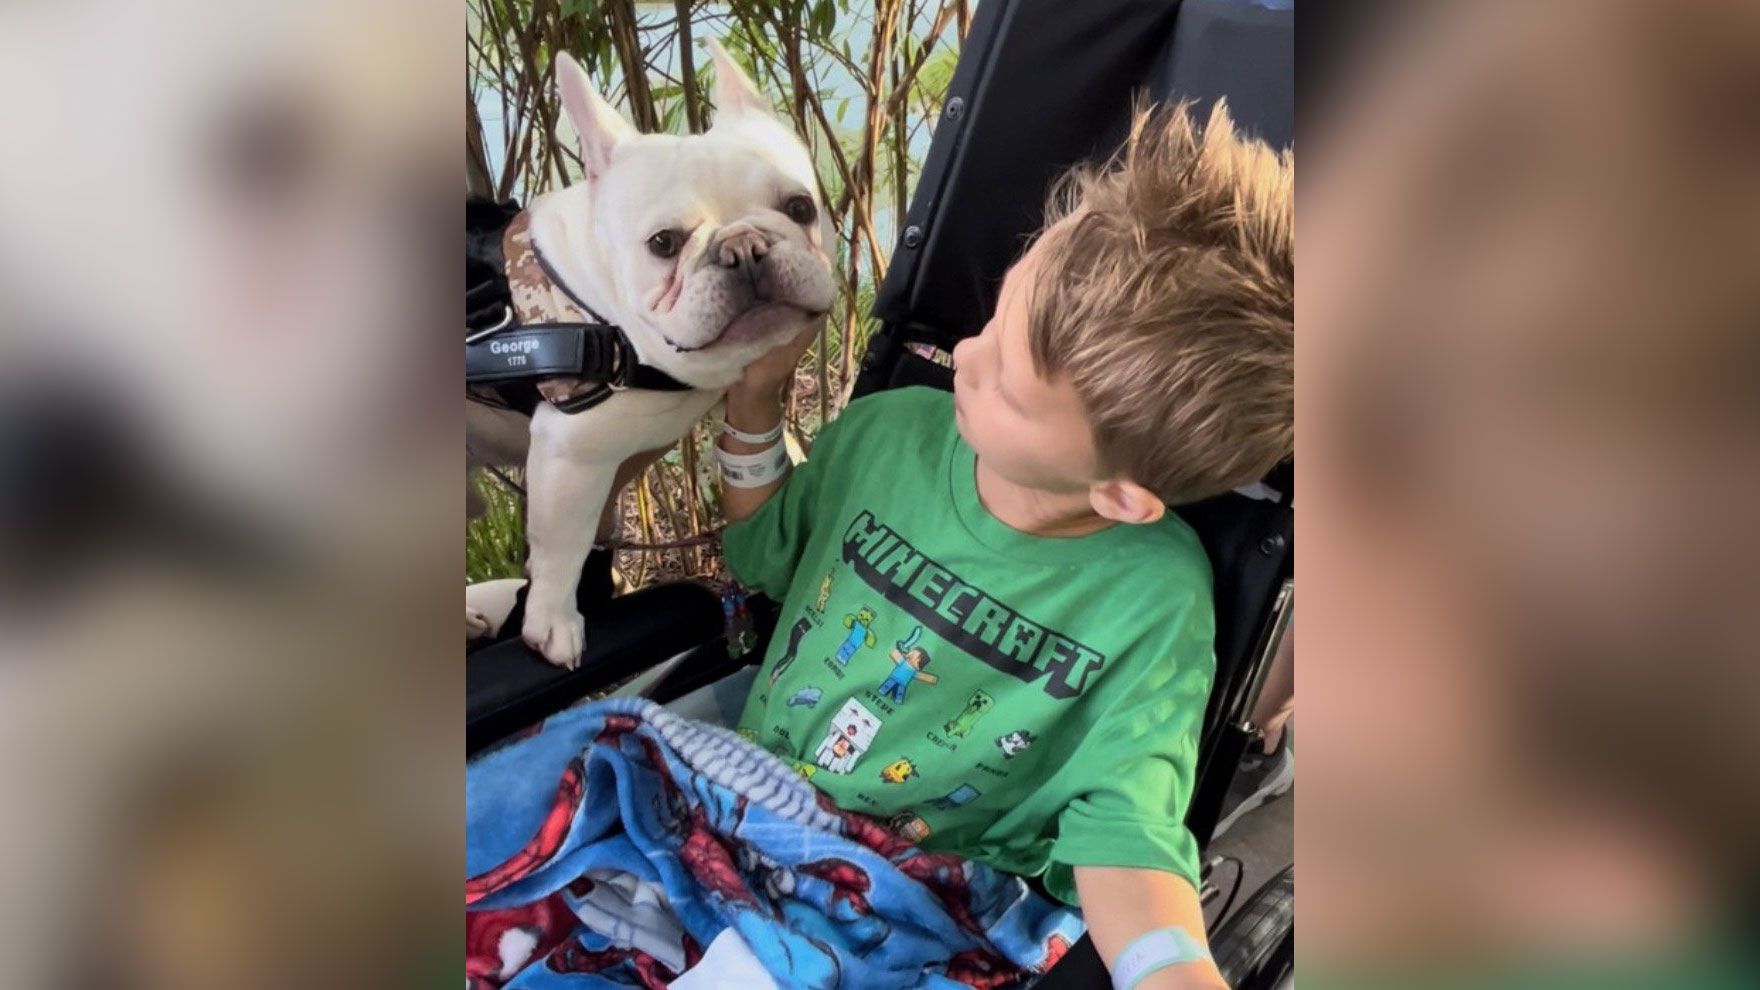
[720,107,1294,988]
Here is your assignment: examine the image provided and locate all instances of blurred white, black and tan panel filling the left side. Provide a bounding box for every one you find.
[0,0,463,988]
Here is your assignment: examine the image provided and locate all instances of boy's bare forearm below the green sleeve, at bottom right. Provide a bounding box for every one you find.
[1075,867,1228,990]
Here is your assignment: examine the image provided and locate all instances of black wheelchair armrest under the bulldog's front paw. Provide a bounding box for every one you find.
[465,581,723,756]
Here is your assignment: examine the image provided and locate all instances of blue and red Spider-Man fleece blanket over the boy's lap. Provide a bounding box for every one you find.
[465,698,1082,990]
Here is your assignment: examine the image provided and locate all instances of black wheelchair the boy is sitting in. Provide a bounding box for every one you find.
[466,0,1295,990]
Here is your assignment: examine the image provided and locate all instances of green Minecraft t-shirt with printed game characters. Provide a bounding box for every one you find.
[725,389,1214,904]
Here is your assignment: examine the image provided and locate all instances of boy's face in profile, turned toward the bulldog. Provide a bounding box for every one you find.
[954,238,1100,495]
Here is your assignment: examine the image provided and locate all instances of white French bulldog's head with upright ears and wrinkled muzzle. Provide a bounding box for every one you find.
[556,44,836,388]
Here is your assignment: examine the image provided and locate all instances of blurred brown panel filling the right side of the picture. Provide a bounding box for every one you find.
[1297,0,1760,986]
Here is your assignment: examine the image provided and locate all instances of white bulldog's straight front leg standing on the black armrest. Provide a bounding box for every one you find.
[521,405,621,668]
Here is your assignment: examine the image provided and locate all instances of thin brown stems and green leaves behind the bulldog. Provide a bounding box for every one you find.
[465,0,975,588]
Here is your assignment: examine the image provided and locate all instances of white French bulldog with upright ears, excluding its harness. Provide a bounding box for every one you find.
[496,42,836,666]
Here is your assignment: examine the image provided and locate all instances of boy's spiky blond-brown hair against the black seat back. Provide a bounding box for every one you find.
[1028,102,1295,504]
